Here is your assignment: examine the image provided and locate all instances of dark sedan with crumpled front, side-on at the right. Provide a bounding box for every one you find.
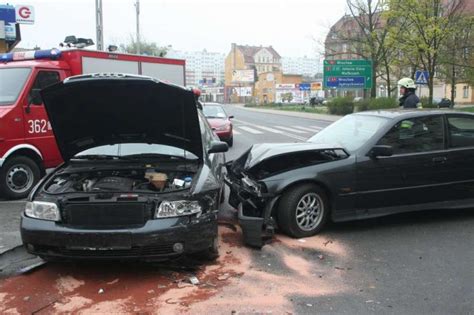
[226,110,474,246]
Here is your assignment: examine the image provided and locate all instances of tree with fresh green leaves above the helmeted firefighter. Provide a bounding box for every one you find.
[388,0,469,104]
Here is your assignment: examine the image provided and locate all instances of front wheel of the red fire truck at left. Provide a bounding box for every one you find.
[0,156,41,199]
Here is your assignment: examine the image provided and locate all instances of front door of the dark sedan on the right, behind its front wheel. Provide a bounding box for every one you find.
[357,115,449,209]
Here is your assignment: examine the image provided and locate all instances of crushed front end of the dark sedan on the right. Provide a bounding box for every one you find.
[225,143,349,248]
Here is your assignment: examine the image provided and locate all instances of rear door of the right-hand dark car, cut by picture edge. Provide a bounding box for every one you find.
[445,113,474,200]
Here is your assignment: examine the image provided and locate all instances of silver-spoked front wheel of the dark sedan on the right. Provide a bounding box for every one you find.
[277,184,329,238]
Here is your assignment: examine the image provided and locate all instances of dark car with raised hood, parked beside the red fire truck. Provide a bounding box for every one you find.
[21,75,227,260]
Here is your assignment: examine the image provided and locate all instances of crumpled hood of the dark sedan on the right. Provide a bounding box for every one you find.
[239,142,342,170]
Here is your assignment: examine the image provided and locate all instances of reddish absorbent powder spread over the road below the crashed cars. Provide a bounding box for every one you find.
[0,226,348,314]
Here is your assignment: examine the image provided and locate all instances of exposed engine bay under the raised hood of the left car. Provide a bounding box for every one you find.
[45,168,193,194]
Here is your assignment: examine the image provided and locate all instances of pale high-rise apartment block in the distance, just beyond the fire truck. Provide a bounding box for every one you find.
[166,49,225,87]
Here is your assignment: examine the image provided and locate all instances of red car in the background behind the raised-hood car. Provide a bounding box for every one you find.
[202,103,234,147]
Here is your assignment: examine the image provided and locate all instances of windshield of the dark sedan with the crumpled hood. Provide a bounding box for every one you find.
[308,115,387,152]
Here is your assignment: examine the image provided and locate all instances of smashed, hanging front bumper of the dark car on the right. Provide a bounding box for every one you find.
[224,165,279,248]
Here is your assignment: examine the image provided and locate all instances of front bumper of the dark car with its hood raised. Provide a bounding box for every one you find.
[21,212,217,260]
